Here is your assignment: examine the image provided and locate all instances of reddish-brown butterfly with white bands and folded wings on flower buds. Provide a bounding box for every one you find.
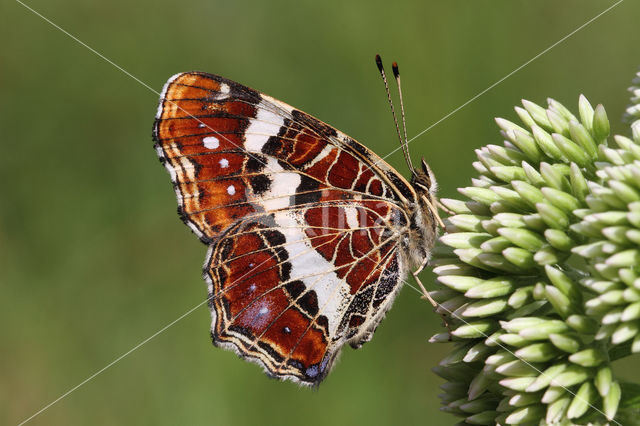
[153,56,441,386]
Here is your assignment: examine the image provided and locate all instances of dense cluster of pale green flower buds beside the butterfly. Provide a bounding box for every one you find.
[431,73,640,425]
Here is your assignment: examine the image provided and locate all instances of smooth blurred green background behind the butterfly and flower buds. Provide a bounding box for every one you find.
[0,0,640,425]
